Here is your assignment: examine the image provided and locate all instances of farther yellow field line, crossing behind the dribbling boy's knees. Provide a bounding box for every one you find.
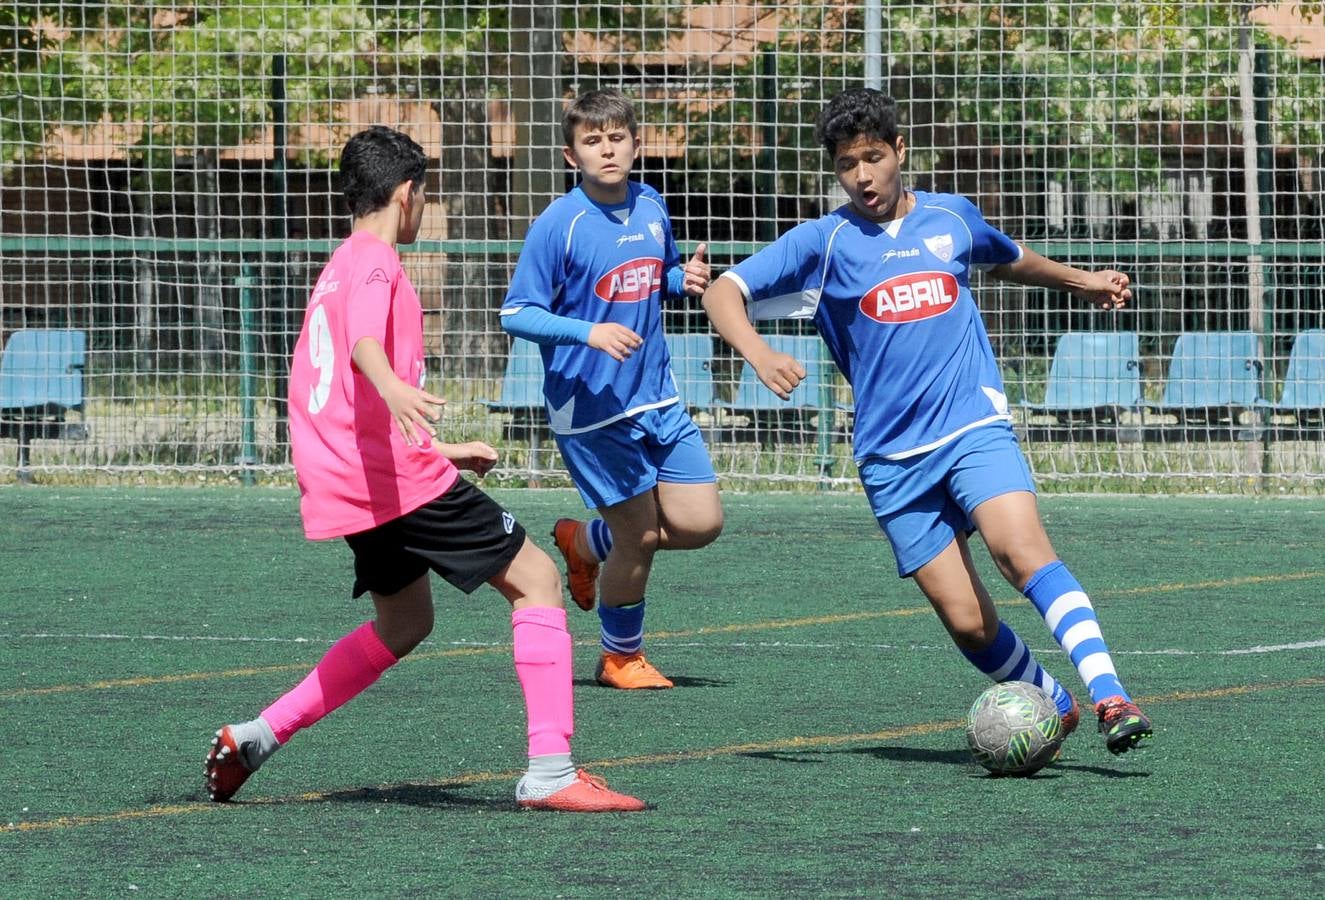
[0,571,1325,700]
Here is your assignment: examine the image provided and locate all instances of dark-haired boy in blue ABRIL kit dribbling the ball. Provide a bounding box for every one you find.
[704,89,1151,753]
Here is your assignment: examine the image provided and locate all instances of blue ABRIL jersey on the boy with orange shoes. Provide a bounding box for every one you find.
[501,182,681,435]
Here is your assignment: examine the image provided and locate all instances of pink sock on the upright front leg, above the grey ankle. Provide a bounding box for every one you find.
[510,606,575,757]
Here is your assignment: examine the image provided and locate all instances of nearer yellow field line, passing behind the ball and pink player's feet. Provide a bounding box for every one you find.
[0,677,1325,834]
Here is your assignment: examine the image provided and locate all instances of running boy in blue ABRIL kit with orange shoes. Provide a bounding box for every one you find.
[501,90,722,689]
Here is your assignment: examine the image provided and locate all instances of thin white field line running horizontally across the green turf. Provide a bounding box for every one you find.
[0,631,1325,656]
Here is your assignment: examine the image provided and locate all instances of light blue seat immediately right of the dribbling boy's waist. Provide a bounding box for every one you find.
[1020,331,1141,422]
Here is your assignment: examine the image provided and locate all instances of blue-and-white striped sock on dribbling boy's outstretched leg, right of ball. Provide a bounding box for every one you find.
[1022,559,1130,704]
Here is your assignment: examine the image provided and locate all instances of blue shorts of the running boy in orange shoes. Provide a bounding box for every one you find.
[555,403,718,509]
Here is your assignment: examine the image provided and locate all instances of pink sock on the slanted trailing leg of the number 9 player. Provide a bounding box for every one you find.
[262,622,396,744]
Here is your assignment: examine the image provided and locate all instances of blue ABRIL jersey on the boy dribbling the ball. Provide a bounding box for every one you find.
[722,191,1022,461]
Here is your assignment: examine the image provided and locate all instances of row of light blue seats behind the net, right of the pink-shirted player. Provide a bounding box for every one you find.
[488,330,1325,443]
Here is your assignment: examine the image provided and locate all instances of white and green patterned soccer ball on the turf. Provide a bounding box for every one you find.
[966,681,1064,775]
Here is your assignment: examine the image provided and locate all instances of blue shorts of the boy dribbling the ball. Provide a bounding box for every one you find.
[860,423,1035,578]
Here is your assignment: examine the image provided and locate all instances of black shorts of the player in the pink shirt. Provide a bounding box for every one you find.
[345,478,525,596]
